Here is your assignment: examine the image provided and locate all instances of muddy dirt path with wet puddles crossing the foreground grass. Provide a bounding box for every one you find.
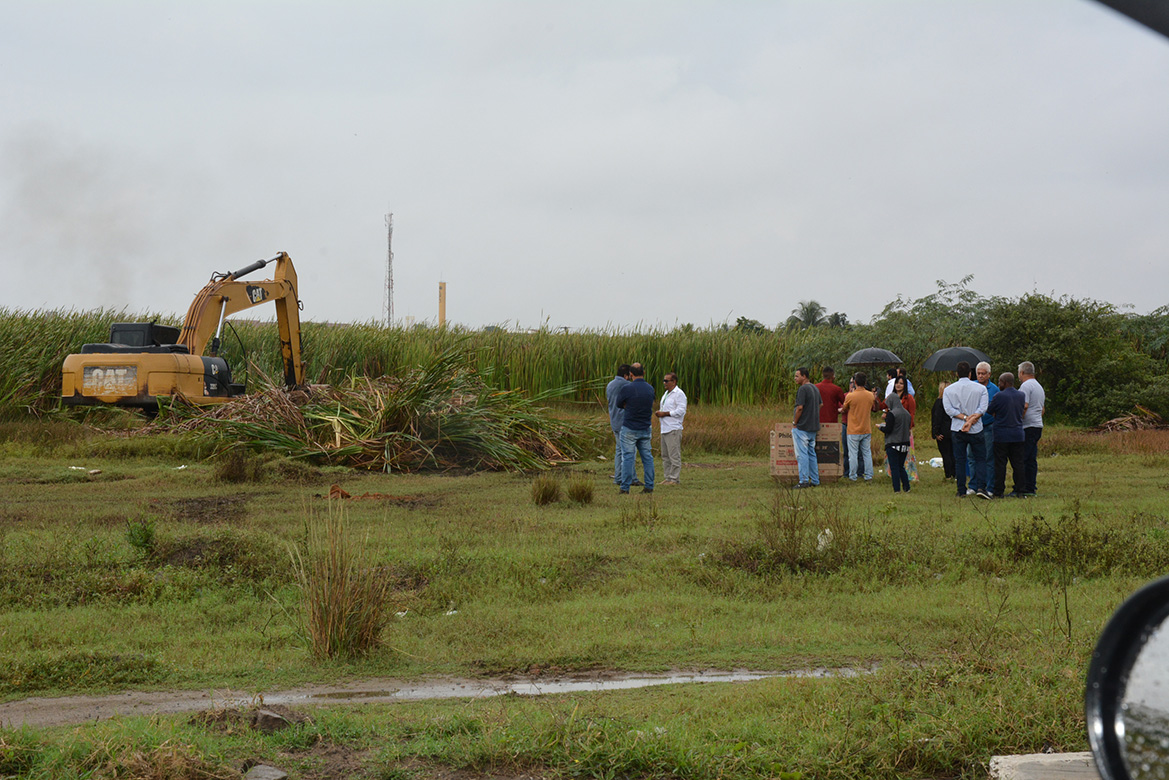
[0,669,871,729]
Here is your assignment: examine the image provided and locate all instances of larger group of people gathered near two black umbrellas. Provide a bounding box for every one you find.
[791,361,1045,498]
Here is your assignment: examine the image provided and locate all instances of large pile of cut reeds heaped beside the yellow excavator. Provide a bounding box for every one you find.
[147,346,589,471]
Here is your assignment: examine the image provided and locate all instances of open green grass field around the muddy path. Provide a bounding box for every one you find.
[0,418,1169,778]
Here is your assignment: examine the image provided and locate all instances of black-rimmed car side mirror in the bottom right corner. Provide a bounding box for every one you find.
[1084,577,1169,780]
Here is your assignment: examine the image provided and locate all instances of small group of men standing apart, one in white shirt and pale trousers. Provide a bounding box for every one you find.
[604,363,686,495]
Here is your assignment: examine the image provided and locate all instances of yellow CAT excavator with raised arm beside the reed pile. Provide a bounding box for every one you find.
[61,251,304,409]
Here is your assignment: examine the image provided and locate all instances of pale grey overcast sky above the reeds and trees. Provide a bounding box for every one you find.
[0,0,1169,329]
